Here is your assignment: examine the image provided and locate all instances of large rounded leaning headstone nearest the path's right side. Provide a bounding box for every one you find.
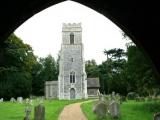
[93,101,107,118]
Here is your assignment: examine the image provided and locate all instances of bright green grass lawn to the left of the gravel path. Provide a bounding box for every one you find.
[0,100,84,120]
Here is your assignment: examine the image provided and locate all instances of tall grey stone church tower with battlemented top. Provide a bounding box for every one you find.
[58,23,87,99]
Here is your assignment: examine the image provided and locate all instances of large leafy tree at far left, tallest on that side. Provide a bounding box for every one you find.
[0,34,36,99]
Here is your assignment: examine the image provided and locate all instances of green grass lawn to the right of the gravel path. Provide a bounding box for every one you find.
[81,101,160,120]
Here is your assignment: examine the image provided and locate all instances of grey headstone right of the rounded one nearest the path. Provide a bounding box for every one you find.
[108,101,120,118]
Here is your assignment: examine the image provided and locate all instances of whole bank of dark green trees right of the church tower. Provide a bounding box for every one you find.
[86,45,159,96]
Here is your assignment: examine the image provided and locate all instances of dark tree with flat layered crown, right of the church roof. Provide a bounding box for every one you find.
[100,48,126,94]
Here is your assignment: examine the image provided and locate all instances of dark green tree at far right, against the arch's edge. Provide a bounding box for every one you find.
[127,45,159,95]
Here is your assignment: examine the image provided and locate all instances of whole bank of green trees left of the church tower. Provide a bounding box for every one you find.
[0,34,58,100]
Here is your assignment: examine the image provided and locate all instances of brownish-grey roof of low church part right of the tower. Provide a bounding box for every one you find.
[87,78,100,88]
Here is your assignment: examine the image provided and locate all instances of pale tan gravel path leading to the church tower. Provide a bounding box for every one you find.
[58,102,87,120]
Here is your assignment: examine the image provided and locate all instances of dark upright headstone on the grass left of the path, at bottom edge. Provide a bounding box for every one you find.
[34,104,45,120]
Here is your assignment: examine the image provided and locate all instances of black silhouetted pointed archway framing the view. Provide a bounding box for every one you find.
[0,0,160,78]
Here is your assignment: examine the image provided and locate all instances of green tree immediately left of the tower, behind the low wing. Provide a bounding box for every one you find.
[32,55,59,96]
